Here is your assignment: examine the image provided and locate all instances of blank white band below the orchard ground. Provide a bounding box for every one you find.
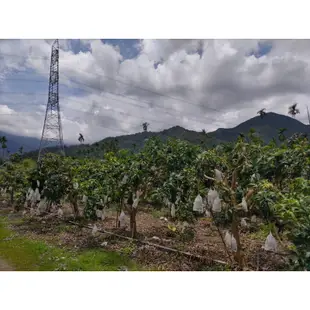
[0,272,308,310]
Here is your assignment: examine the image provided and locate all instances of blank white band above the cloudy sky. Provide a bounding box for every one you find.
[0,0,309,39]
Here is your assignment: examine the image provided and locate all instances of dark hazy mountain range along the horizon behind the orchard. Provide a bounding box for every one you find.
[0,112,310,158]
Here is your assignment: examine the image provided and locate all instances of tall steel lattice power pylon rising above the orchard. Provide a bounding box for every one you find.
[38,40,65,162]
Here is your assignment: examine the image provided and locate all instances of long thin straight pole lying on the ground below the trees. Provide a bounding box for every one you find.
[69,221,229,265]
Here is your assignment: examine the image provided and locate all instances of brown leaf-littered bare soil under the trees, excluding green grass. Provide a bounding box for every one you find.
[0,208,287,271]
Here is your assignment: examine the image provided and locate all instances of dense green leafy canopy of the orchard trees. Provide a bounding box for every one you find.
[0,130,310,269]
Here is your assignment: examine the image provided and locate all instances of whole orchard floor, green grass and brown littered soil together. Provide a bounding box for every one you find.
[0,207,287,271]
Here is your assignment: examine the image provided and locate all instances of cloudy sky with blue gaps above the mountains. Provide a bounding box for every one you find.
[0,39,310,144]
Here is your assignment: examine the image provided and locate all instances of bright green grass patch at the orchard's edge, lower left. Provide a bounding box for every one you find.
[0,216,138,271]
